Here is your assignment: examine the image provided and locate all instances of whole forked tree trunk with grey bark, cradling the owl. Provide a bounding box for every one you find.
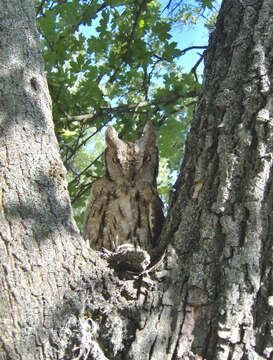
[0,0,273,360]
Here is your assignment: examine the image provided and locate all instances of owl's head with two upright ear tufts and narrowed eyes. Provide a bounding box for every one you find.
[105,122,158,186]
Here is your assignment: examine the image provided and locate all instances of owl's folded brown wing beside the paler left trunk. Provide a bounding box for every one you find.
[83,178,112,249]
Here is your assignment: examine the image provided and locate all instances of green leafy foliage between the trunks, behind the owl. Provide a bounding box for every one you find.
[35,0,217,228]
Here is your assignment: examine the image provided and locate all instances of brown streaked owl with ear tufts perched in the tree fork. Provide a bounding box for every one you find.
[83,122,164,252]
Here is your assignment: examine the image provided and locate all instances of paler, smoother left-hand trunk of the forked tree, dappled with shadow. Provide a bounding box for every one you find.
[0,0,101,360]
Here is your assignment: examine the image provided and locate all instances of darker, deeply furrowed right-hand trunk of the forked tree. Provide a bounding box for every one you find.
[150,0,273,360]
